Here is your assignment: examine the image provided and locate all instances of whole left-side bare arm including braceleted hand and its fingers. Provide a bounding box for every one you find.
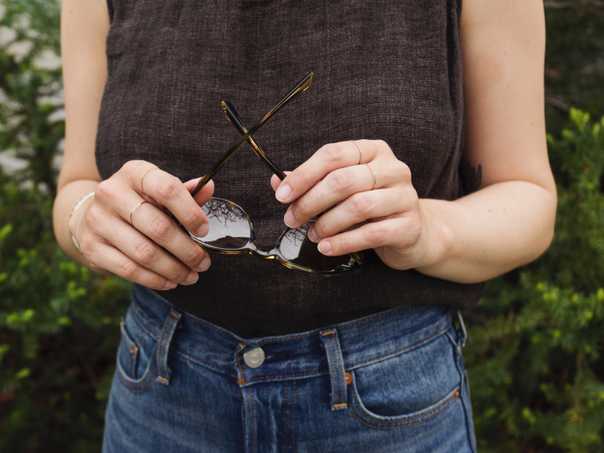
[53,0,214,289]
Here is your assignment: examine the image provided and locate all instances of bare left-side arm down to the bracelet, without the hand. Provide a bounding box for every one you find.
[53,0,109,264]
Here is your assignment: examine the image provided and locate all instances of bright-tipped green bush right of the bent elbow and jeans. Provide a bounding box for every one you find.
[467,109,604,453]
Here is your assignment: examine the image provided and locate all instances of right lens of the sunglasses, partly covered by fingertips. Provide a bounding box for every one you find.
[278,222,350,271]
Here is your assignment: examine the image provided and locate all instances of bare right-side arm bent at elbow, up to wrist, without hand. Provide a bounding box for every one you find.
[418,0,557,282]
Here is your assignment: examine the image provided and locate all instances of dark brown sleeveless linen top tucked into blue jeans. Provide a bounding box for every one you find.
[96,0,481,336]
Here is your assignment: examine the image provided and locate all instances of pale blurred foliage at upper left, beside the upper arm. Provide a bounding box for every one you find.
[0,0,65,191]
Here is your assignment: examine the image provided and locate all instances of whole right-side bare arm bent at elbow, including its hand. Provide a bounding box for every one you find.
[271,0,557,283]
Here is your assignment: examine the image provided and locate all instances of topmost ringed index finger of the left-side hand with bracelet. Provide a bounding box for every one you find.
[124,160,208,236]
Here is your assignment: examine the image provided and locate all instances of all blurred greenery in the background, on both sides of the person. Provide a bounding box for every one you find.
[0,0,604,452]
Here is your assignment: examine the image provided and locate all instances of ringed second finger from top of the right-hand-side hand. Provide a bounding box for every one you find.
[284,159,400,228]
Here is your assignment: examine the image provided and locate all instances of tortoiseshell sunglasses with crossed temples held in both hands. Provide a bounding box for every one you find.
[179,71,363,275]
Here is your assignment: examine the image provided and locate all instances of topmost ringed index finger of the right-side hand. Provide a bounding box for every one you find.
[274,140,382,203]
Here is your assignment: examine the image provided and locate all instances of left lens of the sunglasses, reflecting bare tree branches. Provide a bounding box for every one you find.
[199,197,252,249]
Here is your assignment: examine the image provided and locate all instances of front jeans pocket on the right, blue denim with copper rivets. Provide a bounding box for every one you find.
[349,333,462,429]
